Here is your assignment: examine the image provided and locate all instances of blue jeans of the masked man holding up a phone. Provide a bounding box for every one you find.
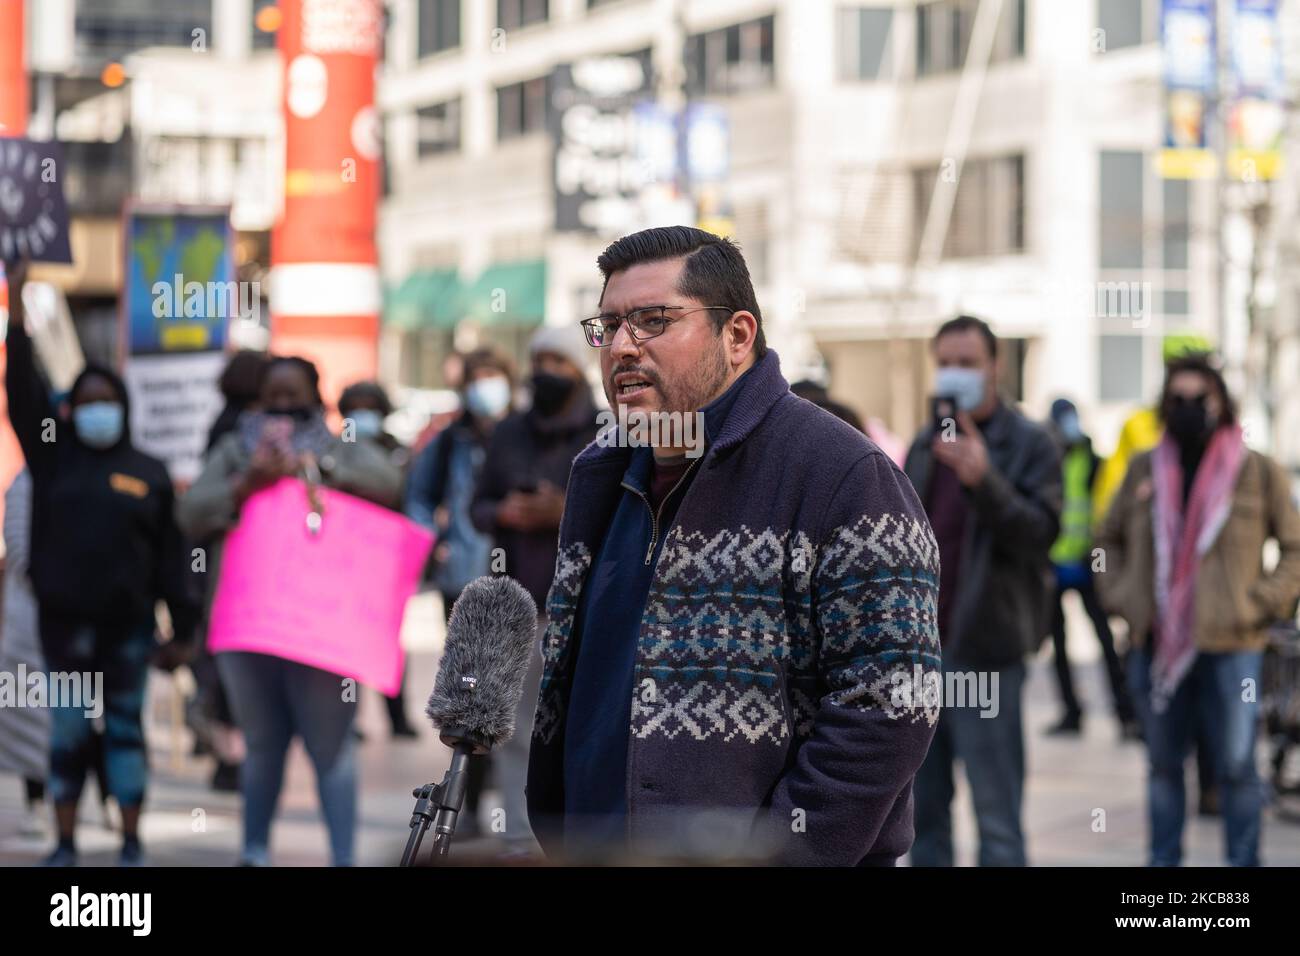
[911,663,1024,866]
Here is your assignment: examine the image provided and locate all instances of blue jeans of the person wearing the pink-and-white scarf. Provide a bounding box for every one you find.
[1128,646,1264,866]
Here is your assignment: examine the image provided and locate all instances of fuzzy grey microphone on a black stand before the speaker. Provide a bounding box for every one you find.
[402,576,537,866]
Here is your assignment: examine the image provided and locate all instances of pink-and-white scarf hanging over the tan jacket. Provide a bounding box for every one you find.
[1151,425,1245,713]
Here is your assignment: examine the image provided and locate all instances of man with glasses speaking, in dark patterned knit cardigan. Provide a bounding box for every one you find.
[528,226,940,866]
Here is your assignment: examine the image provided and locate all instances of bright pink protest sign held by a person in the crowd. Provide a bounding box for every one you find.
[208,479,433,696]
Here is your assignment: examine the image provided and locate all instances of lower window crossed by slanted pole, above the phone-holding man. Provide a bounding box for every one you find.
[913,155,1024,259]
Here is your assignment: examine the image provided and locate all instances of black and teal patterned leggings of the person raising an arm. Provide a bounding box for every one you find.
[40,613,157,808]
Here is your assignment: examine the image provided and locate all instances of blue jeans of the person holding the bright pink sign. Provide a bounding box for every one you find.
[217,652,356,866]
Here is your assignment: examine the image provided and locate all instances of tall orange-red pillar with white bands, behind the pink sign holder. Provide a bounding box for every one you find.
[270,0,384,403]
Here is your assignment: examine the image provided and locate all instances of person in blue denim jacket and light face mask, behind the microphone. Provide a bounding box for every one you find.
[403,349,515,839]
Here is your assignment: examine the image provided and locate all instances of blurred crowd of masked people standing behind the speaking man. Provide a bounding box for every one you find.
[0,251,1300,865]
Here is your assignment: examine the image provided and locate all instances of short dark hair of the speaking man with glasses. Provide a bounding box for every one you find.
[595,226,767,359]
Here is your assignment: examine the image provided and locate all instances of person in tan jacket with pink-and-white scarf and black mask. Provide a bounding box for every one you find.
[1096,356,1300,866]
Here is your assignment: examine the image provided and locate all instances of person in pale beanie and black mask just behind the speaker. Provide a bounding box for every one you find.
[469,325,597,851]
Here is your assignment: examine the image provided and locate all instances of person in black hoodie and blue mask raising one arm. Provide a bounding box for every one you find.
[5,260,199,865]
